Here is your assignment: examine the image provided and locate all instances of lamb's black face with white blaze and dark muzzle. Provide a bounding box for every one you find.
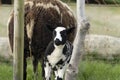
[53,27,67,46]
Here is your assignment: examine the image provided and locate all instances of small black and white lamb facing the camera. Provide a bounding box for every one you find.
[43,27,73,80]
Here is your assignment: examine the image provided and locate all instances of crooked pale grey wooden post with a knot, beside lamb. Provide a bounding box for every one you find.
[65,0,89,80]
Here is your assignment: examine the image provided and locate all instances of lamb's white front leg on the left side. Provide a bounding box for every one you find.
[44,62,51,80]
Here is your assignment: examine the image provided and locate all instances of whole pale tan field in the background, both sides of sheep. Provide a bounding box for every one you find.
[0,3,120,37]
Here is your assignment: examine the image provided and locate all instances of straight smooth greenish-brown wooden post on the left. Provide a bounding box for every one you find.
[13,0,24,80]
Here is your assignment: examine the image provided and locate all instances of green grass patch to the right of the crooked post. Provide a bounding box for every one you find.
[77,61,120,80]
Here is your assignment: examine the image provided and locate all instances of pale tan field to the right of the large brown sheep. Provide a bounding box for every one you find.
[69,3,120,37]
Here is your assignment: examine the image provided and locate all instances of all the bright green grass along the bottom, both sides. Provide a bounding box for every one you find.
[0,60,120,80]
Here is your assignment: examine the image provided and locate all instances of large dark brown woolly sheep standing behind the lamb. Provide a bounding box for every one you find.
[8,0,77,80]
